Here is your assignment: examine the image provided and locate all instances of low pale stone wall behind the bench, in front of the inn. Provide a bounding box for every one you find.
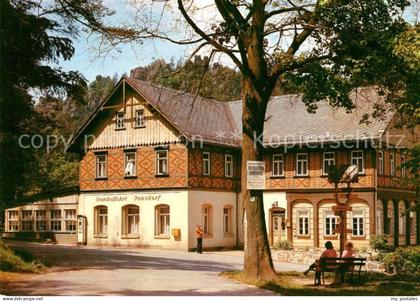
[271,248,385,272]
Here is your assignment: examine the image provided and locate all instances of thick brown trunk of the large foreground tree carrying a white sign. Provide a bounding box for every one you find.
[241,83,276,280]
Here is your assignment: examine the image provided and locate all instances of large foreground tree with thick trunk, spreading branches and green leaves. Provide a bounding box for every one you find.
[82,0,416,279]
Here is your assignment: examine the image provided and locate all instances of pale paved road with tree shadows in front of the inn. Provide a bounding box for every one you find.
[0,242,305,296]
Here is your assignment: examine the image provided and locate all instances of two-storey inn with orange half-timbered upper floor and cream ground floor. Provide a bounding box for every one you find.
[6,77,420,250]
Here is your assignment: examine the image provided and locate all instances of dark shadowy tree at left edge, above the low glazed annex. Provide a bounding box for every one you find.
[0,0,111,212]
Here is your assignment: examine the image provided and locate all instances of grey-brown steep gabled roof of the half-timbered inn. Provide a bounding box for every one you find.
[69,77,393,150]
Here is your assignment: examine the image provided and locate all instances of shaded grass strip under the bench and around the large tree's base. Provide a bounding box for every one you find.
[221,271,420,296]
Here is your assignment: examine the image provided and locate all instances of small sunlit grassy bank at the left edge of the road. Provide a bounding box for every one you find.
[0,241,45,273]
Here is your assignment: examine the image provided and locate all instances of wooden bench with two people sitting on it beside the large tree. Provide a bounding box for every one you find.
[315,257,366,286]
